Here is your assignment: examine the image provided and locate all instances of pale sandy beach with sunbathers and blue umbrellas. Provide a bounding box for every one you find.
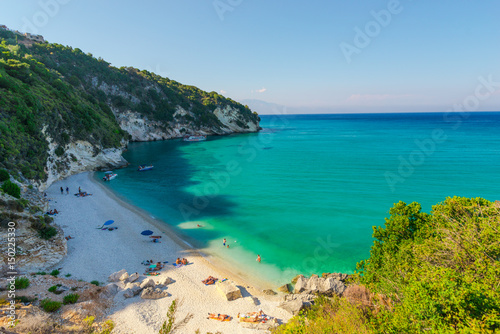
[46,173,291,334]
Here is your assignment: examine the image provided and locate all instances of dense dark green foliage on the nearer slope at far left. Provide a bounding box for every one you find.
[0,29,125,179]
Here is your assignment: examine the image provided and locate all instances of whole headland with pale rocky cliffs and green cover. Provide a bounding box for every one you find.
[0,29,260,191]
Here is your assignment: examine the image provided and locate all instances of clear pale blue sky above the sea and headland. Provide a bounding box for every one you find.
[0,0,500,112]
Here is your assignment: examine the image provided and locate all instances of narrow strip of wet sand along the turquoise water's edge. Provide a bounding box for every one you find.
[88,172,276,293]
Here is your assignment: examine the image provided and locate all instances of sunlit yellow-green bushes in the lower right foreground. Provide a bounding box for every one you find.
[279,197,500,333]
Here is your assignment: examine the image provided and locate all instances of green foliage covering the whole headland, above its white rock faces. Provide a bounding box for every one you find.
[0,29,258,180]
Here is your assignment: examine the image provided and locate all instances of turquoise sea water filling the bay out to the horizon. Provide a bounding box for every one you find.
[96,113,500,284]
